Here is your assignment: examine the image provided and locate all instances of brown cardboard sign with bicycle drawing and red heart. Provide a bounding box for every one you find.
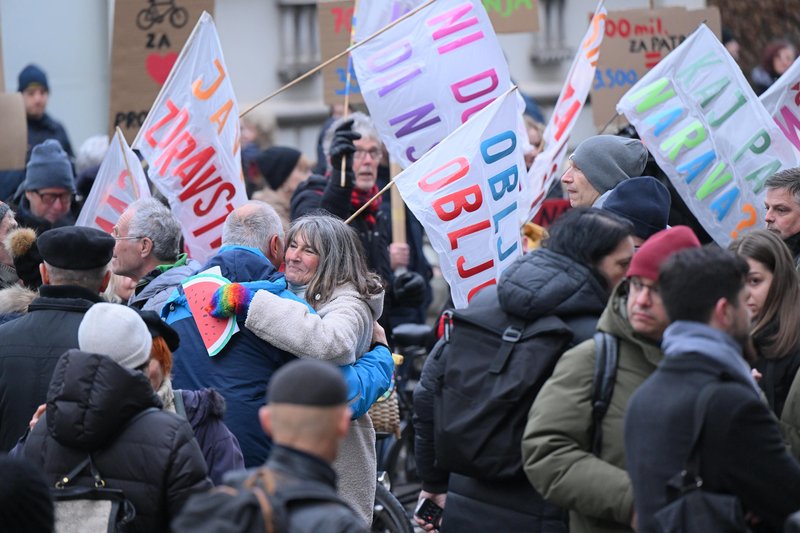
[109,0,214,142]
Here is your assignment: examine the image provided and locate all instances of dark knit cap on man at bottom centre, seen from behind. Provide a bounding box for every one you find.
[267,359,347,407]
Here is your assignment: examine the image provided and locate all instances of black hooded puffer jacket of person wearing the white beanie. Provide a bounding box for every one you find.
[23,350,211,532]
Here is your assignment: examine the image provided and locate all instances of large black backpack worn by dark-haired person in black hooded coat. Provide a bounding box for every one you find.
[432,287,573,480]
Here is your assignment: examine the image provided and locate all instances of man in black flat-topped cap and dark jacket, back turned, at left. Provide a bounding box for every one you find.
[0,226,114,451]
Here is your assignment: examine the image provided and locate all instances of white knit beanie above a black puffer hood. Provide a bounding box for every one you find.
[78,302,153,368]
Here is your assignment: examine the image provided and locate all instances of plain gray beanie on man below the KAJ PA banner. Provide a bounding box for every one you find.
[570,135,647,194]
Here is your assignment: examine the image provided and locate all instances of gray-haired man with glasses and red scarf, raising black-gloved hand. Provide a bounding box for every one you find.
[290,112,429,344]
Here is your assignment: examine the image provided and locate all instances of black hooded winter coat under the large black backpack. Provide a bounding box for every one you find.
[414,249,608,532]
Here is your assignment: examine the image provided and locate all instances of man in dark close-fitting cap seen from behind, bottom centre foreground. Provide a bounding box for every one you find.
[172,359,370,533]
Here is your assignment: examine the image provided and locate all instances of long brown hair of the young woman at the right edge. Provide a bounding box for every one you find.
[729,230,800,359]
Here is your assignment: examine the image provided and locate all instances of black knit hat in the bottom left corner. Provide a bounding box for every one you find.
[0,455,54,533]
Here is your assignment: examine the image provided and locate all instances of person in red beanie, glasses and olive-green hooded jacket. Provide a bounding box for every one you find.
[522,226,700,533]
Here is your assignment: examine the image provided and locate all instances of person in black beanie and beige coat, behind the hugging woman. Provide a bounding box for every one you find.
[252,146,311,229]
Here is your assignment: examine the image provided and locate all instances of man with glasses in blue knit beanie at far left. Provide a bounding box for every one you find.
[14,139,75,234]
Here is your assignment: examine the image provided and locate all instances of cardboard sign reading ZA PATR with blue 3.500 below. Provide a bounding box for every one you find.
[591,7,722,129]
